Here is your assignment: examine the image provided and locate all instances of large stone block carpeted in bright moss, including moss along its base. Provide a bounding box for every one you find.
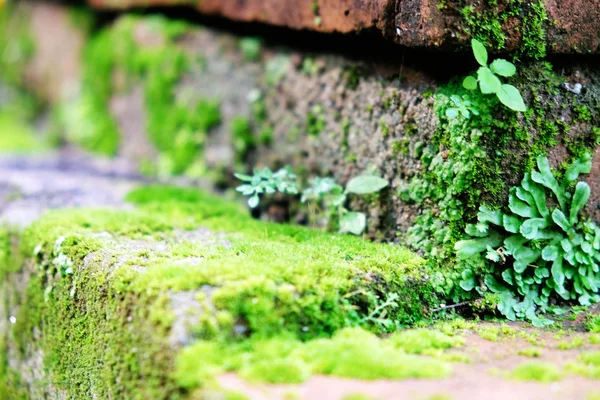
[0,187,440,399]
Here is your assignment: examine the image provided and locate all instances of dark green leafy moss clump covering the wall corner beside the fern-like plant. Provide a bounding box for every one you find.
[400,63,597,306]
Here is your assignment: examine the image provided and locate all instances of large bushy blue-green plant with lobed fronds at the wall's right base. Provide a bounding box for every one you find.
[455,154,600,326]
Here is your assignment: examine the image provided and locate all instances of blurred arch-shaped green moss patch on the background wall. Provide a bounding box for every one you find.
[56,16,221,175]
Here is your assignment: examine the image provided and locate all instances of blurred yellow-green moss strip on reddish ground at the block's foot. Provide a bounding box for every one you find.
[176,328,451,388]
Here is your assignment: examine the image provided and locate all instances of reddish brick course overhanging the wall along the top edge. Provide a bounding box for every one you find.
[88,0,600,53]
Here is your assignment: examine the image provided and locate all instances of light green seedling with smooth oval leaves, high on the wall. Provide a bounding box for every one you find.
[463,39,527,112]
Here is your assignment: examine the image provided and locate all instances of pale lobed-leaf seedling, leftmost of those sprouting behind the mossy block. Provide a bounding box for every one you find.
[235,167,298,208]
